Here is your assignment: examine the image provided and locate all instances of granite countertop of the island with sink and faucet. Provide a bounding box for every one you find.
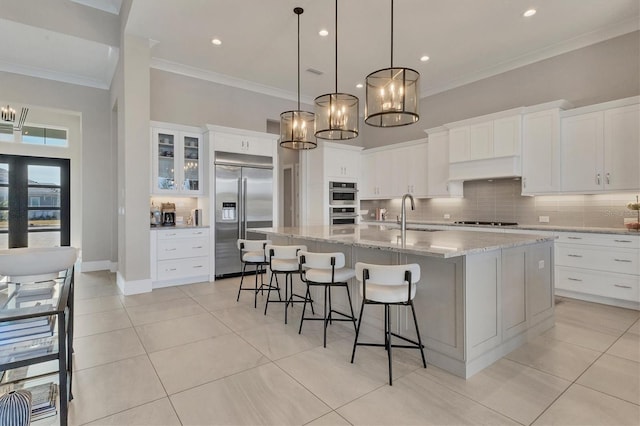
[251,225,555,258]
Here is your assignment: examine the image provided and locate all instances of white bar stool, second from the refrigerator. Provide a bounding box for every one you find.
[264,244,313,324]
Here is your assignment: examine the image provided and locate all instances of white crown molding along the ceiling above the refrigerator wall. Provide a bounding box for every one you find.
[149,58,313,105]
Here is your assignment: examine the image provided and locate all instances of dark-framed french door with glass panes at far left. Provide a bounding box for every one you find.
[0,154,71,249]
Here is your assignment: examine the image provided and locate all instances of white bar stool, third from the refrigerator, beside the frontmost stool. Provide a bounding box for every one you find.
[298,251,356,348]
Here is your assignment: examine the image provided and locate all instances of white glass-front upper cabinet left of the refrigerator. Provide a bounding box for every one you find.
[151,128,203,195]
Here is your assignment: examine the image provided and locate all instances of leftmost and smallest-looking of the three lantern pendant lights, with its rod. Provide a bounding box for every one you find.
[280,7,318,150]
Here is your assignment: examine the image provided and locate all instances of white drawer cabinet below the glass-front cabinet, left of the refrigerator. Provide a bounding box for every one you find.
[151,228,210,288]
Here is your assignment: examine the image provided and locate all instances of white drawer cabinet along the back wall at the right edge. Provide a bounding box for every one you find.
[555,232,640,309]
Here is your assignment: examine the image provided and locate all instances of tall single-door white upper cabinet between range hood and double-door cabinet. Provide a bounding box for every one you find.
[522,105,568,195]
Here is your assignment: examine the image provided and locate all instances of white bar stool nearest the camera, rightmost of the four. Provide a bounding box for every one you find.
[351,262,427,385]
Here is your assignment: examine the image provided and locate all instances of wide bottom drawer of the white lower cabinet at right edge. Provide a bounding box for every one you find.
[555,266,640,302]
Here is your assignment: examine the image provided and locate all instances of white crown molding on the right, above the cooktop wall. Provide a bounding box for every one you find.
[420,18,640,98]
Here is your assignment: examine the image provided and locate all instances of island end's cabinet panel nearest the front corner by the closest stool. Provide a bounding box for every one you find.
[465,250,502,359]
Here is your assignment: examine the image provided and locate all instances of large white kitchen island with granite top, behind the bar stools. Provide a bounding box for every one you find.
[250,225,554,378]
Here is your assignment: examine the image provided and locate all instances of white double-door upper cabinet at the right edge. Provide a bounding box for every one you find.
[562,98,640,193]
